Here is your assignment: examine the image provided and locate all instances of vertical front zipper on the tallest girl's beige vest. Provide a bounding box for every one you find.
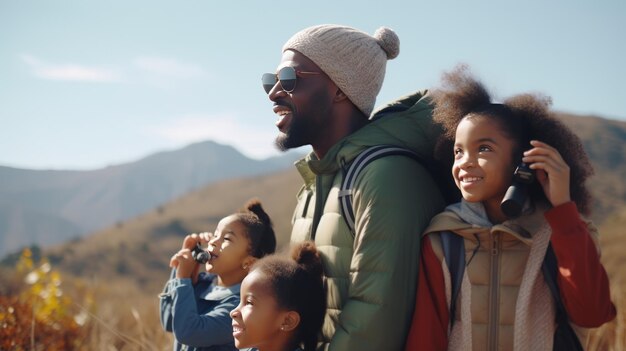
[487,234,500,350]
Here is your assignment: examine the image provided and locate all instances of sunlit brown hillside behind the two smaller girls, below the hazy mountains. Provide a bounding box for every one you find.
[39,169,302,292]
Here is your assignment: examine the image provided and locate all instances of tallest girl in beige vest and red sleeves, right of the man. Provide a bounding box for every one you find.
[406,67,616,350]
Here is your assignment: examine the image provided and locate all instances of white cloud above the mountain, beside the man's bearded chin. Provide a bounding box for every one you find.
[147,115,279,158]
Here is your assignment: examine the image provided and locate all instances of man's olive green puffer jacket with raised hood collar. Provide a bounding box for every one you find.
[291,91,444,351]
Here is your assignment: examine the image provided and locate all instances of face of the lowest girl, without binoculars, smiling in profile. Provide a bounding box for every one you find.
[230,269,287,350]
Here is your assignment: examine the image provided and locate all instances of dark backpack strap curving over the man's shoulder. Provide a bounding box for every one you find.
[339,145,420,236]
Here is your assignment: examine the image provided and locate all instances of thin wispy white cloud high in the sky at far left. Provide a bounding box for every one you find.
[21,54,121,83]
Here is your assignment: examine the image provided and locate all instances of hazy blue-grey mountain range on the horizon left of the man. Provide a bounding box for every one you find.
[0,141,296,257]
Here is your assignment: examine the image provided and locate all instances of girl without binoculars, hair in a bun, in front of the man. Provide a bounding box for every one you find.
[230,242,326,351]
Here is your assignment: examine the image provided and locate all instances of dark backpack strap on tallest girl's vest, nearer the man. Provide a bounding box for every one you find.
[439,231,465,326]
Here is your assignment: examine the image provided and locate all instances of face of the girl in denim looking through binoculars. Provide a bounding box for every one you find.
[206,216,250,277]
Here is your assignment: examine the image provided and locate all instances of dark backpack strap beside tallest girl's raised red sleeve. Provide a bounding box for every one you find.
[541,244,583,351]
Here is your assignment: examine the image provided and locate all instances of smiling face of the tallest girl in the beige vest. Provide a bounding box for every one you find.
[452,115,515,213]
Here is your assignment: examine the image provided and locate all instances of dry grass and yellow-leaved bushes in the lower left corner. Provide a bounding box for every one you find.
[0,250,172,351]
